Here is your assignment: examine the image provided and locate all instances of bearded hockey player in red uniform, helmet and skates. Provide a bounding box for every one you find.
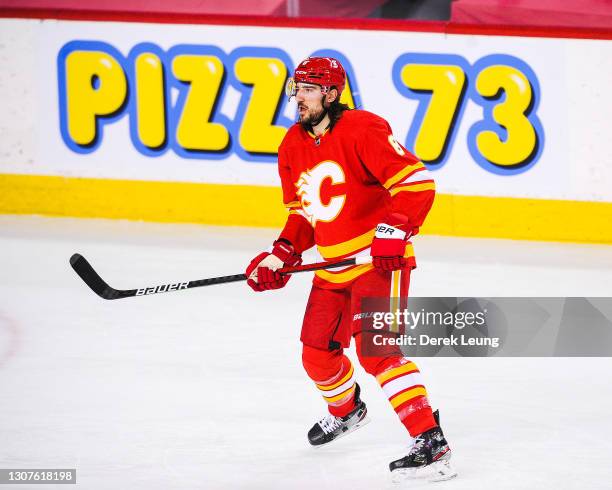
[246,57,455,479]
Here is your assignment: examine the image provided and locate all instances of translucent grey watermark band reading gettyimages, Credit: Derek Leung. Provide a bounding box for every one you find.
[353,297,612,357]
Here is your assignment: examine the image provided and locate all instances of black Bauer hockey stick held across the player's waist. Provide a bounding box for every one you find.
[70,254,371,299]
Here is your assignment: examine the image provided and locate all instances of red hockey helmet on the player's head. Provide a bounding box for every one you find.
[287,57,346,98]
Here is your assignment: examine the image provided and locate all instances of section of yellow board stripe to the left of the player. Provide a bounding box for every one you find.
[0,174,287,227]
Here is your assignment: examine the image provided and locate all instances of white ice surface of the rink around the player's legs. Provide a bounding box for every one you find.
[0,216,612,490]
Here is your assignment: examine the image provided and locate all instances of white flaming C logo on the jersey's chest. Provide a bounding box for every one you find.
[295,160,346,226]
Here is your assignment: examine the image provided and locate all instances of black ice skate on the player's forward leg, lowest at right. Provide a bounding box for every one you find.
[389,414,457,483]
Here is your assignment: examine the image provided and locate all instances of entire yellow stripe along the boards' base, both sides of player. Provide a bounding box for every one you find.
[0,174,612,245]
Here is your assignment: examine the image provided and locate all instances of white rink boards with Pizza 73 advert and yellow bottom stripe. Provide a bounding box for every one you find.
[0,15,612,242]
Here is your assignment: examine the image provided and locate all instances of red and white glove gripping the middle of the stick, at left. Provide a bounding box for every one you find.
[245,240,302,292]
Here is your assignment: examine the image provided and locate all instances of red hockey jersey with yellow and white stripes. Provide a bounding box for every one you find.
[278,110,435,288]
